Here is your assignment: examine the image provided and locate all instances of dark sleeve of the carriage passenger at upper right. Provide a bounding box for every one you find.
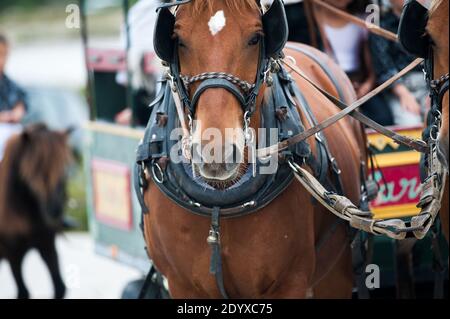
[369,34,399,83]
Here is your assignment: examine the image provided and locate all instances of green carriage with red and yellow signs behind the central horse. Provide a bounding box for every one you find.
[82,0,448,297]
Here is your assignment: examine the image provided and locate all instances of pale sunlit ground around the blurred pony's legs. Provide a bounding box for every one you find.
[0,233,141,299]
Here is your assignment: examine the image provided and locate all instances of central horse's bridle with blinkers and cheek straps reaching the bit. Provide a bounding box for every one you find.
[155,0,288,159]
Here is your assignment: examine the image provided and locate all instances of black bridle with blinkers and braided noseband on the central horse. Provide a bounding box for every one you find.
[155,0,288,121]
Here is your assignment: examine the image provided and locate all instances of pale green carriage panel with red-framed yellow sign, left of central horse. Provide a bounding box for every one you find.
[85,122,150,271]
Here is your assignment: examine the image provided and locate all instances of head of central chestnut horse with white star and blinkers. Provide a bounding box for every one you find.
[155,0,287,188]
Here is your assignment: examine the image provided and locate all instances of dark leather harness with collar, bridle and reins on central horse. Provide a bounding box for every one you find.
[135,0,449,298]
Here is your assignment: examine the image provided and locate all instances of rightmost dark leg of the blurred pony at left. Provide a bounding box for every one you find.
[37,234,66,299]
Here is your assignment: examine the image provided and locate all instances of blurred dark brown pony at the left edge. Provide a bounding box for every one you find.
[0,124,71,298]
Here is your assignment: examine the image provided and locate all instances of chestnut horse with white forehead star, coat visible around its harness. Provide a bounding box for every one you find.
[144,0,365,298]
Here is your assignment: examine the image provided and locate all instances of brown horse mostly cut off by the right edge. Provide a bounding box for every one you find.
[427,0,449,241]
